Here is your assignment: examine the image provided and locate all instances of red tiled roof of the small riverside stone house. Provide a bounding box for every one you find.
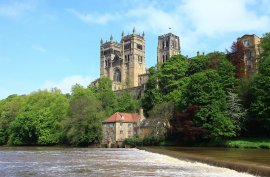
[103,112,139,123]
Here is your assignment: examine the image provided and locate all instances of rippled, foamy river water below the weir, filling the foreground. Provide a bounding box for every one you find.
[0,147,252,177]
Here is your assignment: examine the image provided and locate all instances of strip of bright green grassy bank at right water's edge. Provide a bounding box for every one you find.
[224,138,270,149]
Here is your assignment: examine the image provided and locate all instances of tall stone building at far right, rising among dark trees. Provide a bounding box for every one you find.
[237,34,261,77]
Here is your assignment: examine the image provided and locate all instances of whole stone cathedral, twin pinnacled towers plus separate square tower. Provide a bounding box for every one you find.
[100,28,180,91]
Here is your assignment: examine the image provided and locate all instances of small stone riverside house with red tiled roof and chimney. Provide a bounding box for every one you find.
[102,110,145,147]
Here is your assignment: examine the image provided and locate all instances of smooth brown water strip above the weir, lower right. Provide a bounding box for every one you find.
[139,147,270,176]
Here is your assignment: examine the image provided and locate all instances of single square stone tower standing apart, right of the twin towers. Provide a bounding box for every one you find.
[157,33,180,63]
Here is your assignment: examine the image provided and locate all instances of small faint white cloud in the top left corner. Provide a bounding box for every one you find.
[0,0,35,18]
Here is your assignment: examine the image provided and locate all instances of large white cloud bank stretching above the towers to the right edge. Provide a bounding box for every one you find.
[64,0,270,55]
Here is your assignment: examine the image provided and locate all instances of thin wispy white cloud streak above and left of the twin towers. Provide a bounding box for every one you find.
[67,9,120,25]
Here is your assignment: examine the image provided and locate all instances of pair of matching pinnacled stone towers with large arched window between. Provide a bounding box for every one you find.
[100,28,146,90]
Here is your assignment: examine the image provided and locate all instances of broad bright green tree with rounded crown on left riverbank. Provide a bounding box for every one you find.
[9,89,68,145]
